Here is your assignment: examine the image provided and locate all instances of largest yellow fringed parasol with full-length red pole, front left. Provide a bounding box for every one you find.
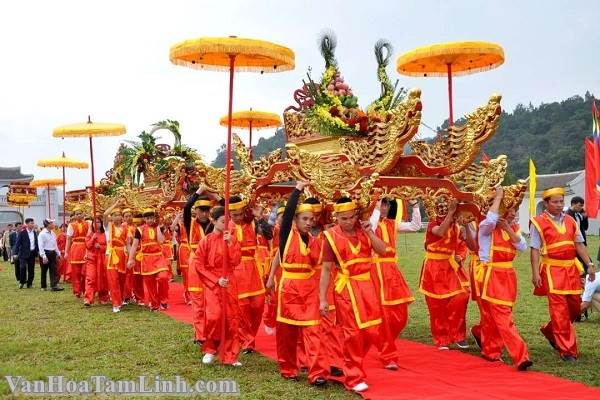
[169,36,295,343]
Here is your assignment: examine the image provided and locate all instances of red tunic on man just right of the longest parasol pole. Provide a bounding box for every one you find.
[231,222,265,299]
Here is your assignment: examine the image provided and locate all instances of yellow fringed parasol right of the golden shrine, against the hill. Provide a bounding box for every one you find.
[396,42,504,126]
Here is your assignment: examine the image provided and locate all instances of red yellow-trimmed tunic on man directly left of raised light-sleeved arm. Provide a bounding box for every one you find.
[419,220,465,299]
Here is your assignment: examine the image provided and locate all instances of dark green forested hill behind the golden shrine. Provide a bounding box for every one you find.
[213,92,593,181]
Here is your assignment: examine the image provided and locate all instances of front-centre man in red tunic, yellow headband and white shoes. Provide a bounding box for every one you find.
[320,198,386,392]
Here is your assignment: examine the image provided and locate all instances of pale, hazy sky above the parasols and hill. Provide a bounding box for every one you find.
[0,0,600,190]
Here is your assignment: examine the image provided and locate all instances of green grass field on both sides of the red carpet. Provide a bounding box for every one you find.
[0,234,600,399]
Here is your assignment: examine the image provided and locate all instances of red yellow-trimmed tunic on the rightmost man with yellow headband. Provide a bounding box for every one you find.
[531,213,583,296]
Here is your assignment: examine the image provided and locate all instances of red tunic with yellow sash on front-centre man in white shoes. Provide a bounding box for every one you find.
[324,225,382,329]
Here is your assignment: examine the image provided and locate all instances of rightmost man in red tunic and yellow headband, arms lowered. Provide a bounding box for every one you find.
[530,188,596,362]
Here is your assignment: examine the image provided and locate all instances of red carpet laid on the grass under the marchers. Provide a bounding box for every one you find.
[166,284,600,400]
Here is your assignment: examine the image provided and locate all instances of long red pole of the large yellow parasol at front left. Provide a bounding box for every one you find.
[220,54,235,355]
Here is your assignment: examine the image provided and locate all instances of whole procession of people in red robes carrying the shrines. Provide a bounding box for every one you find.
[14,181,596,392]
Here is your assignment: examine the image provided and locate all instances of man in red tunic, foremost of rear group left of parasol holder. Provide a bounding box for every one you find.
[127,209,169,311]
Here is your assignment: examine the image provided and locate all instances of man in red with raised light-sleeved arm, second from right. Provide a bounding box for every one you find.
[478,187,533,371]
